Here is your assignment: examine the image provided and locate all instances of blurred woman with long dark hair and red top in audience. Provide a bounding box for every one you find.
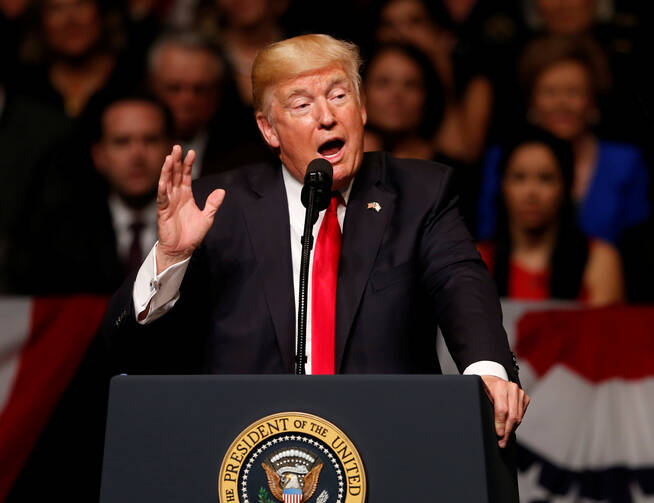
[479,128,625,305]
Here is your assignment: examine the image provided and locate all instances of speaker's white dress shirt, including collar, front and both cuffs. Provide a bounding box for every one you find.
[133,167,508,379]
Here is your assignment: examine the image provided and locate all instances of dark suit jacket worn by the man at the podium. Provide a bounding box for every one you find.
[105,152,517,380]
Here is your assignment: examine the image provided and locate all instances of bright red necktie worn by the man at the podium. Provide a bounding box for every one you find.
[311,193,342,374]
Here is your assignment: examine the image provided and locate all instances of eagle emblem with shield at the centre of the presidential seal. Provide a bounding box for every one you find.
[261,449,323,503]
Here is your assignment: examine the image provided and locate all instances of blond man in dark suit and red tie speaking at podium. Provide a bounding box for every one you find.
[107,35,529,446]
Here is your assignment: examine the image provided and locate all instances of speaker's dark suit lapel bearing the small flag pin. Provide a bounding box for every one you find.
[334,154,395,372]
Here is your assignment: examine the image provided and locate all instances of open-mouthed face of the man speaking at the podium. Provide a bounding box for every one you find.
[257,64,366,189]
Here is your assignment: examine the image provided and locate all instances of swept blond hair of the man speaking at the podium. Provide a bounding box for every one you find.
[252,34,361,112]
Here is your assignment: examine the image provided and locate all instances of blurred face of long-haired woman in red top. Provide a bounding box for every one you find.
[502,143,565,231]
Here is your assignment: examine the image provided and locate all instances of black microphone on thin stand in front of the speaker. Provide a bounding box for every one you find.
[295,158,334,375]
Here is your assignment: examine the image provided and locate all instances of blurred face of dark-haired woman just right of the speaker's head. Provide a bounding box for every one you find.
[364,49,426,134]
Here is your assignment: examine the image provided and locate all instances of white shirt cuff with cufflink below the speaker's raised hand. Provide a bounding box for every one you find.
[132,241,191,325]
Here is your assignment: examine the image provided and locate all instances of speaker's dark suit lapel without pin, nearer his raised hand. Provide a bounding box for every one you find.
[244,166,295,369]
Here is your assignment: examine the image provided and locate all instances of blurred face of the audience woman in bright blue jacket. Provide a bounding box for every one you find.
[531,61,594,140]
